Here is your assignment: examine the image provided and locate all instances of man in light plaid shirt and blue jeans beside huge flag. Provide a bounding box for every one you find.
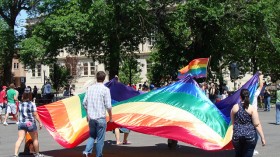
[83,71,113,157]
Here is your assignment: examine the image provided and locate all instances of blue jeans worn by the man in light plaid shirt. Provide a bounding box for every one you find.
[83,118,107,157]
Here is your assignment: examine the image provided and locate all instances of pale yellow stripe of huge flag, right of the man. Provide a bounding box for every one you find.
[113,102,225,146]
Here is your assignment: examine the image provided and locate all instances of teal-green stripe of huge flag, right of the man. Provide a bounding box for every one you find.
[114,91,228,137]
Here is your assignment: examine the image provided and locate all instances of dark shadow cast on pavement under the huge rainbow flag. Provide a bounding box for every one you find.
[37,140,234,157]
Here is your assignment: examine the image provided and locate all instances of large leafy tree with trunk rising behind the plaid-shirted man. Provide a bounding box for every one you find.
[19,0,151,79]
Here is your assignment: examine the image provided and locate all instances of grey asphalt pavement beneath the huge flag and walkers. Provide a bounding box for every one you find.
[0,108,280,157]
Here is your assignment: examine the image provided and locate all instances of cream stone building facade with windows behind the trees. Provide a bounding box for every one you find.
[24,41,152,93]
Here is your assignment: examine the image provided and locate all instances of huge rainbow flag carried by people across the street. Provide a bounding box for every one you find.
[38,74,258,150]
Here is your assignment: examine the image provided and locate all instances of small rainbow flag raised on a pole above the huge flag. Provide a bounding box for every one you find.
[178,58,209,79]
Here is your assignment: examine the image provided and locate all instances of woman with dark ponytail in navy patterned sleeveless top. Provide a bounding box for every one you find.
[231,89,265,157]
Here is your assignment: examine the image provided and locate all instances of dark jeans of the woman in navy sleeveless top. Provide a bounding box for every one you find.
[232,133,258,157]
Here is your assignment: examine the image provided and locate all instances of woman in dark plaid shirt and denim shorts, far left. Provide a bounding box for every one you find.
[14,91,44,157]
